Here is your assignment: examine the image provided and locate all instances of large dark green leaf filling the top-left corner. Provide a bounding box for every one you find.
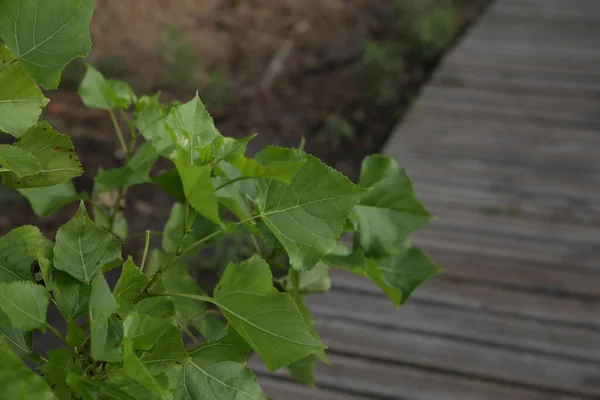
[0,0,94,89]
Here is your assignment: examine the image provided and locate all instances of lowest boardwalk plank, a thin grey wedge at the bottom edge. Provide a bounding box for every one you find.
[258,374,369,400]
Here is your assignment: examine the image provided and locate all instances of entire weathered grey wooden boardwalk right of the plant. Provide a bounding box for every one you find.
[251,0,600,400]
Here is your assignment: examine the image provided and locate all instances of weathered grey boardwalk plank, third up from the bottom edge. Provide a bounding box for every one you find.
[317,318,600,396]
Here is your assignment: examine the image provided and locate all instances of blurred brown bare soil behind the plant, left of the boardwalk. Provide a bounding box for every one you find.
[0,0,487,253]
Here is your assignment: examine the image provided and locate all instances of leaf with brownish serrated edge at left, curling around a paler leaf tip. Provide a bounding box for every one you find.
[1,122,83,189]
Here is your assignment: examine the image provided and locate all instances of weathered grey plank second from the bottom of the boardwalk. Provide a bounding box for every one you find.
[250,354,589,400]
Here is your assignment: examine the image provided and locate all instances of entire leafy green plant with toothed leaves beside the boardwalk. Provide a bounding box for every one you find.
[0,0,439,399]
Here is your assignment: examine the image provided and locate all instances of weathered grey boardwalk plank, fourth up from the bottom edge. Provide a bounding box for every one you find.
[307,290,600,365]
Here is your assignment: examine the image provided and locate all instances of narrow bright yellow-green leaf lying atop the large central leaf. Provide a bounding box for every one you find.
[230,154,307,185]
